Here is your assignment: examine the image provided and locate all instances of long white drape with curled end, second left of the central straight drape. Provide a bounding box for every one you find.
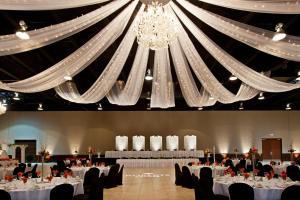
[55,1,144,103]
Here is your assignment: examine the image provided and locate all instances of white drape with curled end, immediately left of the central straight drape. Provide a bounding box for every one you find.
[106,45,149,105]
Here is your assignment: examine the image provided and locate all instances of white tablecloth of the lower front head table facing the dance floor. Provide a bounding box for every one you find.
[117,159,199,168]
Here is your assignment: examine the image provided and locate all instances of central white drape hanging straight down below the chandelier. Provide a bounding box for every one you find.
[150,49,175,108]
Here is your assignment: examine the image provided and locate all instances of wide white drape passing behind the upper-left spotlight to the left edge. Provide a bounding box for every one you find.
[0,0,129,56]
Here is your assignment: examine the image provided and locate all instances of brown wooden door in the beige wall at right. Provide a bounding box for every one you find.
[262,138,282,160]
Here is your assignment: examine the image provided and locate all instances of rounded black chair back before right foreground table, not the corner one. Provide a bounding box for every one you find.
[228,183,254,200]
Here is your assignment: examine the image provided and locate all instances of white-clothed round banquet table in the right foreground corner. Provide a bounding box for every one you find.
[213,176,297,200]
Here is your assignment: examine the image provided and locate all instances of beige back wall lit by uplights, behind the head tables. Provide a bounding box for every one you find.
[0,111,300,154]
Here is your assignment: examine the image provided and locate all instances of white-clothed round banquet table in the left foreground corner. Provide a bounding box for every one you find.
[0,177,83,200]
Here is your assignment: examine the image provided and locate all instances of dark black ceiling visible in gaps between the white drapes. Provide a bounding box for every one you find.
[0,0,300,111]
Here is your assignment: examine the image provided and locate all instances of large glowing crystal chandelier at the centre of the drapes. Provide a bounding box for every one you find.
[137,1,178,50]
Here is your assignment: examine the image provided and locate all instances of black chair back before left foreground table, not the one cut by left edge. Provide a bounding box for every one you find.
[50,183,74,200]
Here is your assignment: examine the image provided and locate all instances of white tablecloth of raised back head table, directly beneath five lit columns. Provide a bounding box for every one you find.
[105,150,204,158]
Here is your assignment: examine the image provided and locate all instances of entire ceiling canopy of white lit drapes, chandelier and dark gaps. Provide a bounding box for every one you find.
[0,0,300,109]
